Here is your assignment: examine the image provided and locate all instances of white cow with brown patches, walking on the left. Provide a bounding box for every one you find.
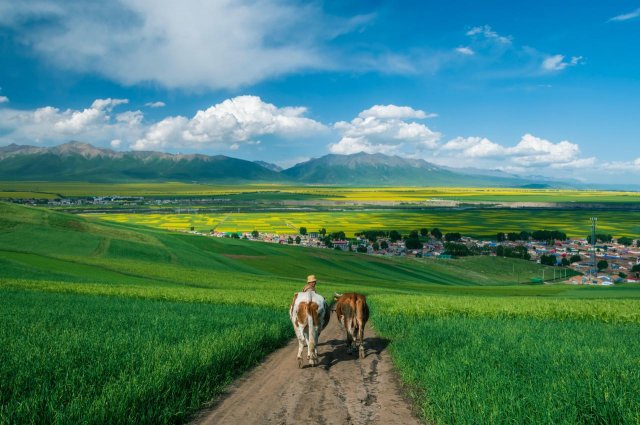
[289,291,331,368]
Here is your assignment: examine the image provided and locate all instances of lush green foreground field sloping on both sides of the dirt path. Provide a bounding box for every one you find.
[0,203,640,424]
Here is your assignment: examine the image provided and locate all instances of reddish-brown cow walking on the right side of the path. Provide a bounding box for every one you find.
[333,293,369,359]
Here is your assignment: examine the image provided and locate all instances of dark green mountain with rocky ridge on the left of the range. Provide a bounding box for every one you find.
[0,142,283,182]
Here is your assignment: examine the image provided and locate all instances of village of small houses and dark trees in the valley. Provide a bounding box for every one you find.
[194,228,640,286]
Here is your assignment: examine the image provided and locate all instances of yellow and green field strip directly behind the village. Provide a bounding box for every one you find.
[91,209,640,238]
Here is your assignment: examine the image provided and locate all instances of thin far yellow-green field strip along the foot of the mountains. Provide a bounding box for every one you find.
[0,181,640,203]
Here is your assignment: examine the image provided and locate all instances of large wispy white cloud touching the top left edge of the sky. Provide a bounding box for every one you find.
[0,0,383,89]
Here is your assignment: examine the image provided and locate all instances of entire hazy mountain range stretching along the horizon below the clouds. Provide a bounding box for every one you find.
[0,142,567,187]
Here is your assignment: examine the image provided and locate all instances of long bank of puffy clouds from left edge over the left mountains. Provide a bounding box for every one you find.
[0,96,326,150]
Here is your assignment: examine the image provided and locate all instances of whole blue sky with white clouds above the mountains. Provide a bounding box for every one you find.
[0,0,640,184]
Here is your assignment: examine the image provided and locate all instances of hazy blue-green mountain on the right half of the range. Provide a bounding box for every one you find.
[282,152,546,186]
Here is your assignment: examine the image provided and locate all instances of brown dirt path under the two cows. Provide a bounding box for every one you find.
[194,314,420,425]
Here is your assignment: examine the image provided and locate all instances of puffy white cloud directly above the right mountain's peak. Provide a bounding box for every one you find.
[329,105,440,155]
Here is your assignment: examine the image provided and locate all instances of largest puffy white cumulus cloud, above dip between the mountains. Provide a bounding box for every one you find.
[132,96,325,150]
